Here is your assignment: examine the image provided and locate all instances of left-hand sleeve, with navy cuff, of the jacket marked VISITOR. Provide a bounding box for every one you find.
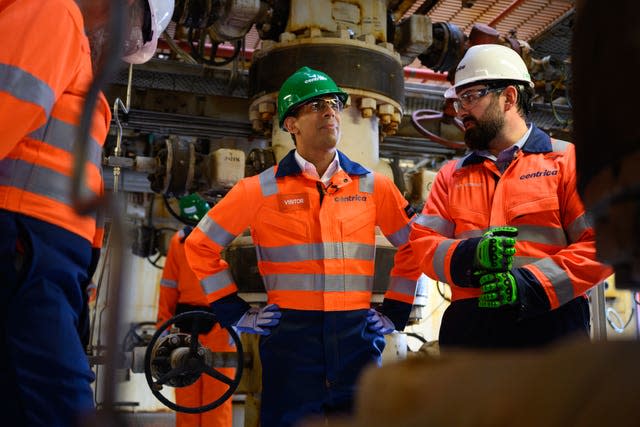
[185,176,261,327]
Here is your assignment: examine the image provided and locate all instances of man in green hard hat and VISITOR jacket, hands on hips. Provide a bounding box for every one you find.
[186,67,420,427]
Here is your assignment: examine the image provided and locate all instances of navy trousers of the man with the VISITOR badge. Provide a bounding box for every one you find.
[260,310,385,427]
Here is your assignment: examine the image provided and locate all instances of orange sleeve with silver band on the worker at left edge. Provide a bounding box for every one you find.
[0,0,85,159]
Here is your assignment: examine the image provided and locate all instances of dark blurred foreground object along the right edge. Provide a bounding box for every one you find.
[572,0,640,289]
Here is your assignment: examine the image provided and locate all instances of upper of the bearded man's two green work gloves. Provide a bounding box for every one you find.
[474,227,518,271]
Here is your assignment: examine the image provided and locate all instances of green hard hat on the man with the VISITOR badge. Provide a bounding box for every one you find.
[278,67,349,129]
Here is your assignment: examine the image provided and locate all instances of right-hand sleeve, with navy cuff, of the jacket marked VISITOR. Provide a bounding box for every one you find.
[376,175,421,331]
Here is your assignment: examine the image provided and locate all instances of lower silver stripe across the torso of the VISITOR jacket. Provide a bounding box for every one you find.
[263,274,373,292]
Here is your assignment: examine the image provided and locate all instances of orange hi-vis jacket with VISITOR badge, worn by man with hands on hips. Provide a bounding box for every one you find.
[186,150,420,320]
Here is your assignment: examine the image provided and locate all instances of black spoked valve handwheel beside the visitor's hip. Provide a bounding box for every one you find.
[144,311,244,414]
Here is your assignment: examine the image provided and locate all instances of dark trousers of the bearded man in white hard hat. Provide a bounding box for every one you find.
[439,297,590,349]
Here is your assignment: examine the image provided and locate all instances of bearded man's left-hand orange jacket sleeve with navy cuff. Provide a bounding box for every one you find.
[409,161,470,286]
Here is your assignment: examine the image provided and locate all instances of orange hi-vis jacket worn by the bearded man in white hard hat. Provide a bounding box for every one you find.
[410,126,612,309]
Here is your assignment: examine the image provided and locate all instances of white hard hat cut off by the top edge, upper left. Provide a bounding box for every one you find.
[122,0,174,64]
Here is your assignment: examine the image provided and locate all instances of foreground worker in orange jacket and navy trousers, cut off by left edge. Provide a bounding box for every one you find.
[0,0,173,427]
